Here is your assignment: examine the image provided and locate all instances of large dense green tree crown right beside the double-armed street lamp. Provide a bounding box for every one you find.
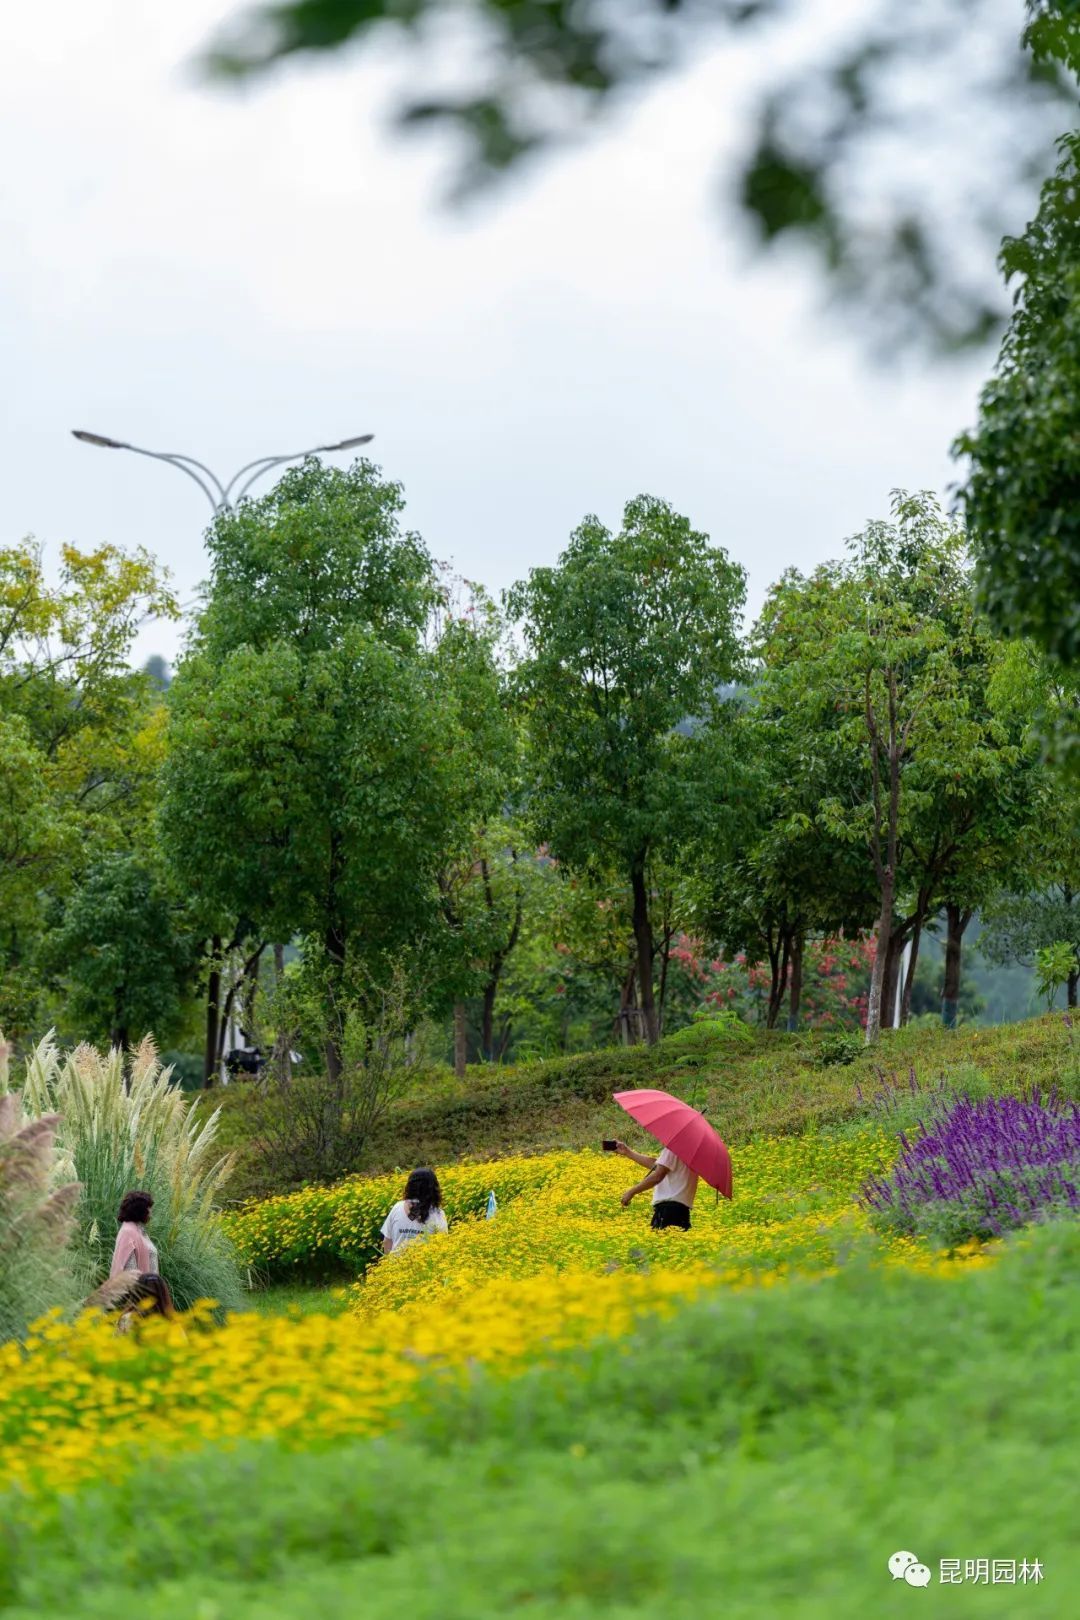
[162,462,488,1068]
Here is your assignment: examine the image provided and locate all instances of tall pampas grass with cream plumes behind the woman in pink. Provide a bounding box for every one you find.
[8,1034,241,1309]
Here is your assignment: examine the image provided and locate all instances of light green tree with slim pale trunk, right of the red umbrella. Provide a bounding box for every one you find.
[764,494,1004,1040]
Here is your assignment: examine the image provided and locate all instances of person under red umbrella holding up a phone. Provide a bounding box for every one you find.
[614,1090,732,1231]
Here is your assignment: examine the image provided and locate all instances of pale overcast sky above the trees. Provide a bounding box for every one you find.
[0,0,988,656]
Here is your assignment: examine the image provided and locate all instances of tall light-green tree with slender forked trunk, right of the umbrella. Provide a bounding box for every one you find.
[761,494,1040,1040]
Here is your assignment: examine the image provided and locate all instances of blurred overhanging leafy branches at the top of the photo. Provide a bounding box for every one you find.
[206,0,1080,348]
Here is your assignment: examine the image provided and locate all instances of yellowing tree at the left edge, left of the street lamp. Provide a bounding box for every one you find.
[0,541,176,1034]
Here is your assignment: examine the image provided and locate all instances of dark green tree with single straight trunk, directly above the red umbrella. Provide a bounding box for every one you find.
[508,496,745,1042]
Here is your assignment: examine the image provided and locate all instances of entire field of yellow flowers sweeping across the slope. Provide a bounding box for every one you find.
[0,1132,981,1490]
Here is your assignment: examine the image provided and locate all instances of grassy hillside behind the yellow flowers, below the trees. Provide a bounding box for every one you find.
[212,1014,1080,1197]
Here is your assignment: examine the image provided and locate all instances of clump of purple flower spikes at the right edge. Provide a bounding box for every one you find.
[863,1092,1080,1247]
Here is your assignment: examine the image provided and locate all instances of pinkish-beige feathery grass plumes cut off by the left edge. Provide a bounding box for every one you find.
[0,1094,79,1340]
